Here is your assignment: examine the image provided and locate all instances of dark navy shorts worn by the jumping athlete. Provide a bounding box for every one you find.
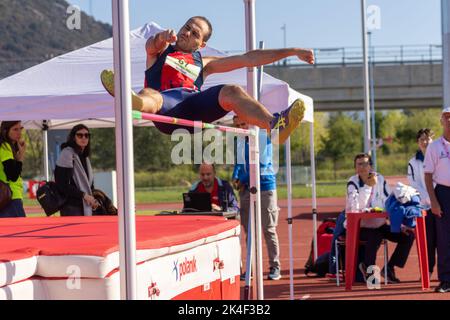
[154,85,228,134]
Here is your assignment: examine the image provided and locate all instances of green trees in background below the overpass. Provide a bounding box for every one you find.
[23,108,441,185]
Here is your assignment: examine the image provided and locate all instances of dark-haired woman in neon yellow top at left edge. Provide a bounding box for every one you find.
[0,121,26,218]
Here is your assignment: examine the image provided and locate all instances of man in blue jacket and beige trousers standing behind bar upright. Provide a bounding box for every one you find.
[232,116,281,280]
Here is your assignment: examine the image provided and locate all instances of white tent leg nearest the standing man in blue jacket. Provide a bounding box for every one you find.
[285,137,294,300]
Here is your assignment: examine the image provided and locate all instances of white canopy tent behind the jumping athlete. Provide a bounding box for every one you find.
[0,10,317,299]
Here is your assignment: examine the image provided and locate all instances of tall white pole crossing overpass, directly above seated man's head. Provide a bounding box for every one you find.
[361,0,371,154]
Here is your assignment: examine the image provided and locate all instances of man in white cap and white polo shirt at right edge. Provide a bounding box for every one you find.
[424,107,450,292]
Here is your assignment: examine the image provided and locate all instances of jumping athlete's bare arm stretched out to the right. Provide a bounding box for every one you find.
[203,48,314,76]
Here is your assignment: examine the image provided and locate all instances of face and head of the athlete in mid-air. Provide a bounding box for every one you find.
[176,18,208,52]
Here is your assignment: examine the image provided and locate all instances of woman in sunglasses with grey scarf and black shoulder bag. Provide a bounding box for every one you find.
[55,124,98,216]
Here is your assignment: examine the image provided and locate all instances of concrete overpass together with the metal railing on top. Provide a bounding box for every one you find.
[264,44,443,111]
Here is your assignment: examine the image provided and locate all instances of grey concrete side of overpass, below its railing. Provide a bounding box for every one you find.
[264,62,443,111]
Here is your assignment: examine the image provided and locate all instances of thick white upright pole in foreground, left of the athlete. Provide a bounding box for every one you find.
[112,0,137,300]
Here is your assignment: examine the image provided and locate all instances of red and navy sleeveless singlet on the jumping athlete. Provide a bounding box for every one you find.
[144,45,203,91]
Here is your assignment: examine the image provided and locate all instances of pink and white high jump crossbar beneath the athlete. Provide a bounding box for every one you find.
[133,110,255,136]
